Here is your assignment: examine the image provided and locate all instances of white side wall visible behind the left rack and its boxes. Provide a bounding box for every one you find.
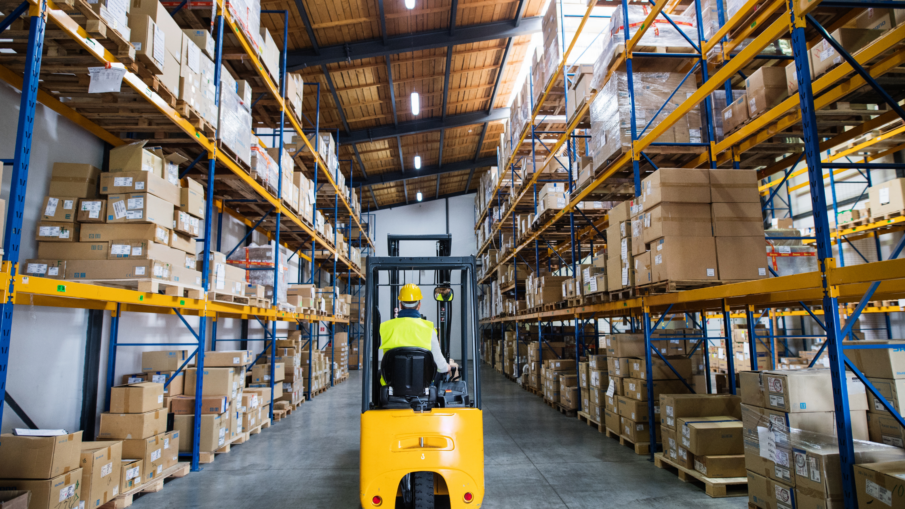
[0,84,297,433]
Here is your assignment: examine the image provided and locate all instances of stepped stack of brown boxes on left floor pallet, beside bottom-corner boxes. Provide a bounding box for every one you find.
[98,382,180,484]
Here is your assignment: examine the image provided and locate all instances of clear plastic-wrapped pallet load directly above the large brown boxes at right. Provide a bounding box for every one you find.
[590,72,702,168]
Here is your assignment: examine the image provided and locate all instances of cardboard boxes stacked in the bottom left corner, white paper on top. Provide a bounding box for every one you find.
[0,431,85,509]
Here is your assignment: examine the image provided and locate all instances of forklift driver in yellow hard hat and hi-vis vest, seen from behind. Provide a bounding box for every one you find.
[379,283,458,385]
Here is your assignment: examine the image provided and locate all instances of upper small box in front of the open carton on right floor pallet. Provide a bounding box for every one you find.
[676,416,745,456]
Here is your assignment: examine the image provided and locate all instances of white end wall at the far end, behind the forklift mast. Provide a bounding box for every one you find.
[373,194,477,359]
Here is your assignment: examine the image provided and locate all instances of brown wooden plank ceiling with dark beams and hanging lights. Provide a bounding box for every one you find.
[261,0,544,211]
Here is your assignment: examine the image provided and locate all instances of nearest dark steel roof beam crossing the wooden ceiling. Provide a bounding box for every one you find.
[287,16,542,72]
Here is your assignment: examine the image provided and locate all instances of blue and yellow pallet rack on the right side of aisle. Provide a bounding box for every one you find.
[475,0,905,508]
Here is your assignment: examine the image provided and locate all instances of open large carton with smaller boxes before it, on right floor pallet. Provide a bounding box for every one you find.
[659,394,745,478]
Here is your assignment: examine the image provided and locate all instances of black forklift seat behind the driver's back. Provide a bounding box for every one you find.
[380,347,437,410]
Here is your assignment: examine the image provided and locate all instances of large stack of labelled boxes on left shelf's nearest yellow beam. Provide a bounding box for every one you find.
[25,142,204,299]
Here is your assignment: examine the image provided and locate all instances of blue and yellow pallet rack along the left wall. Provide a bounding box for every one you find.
[0,0,374,471]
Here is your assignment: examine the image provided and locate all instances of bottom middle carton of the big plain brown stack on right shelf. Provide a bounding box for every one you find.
[651,237,719,281]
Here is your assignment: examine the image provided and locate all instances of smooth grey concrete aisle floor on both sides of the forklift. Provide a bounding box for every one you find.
[133,366,747,509]
